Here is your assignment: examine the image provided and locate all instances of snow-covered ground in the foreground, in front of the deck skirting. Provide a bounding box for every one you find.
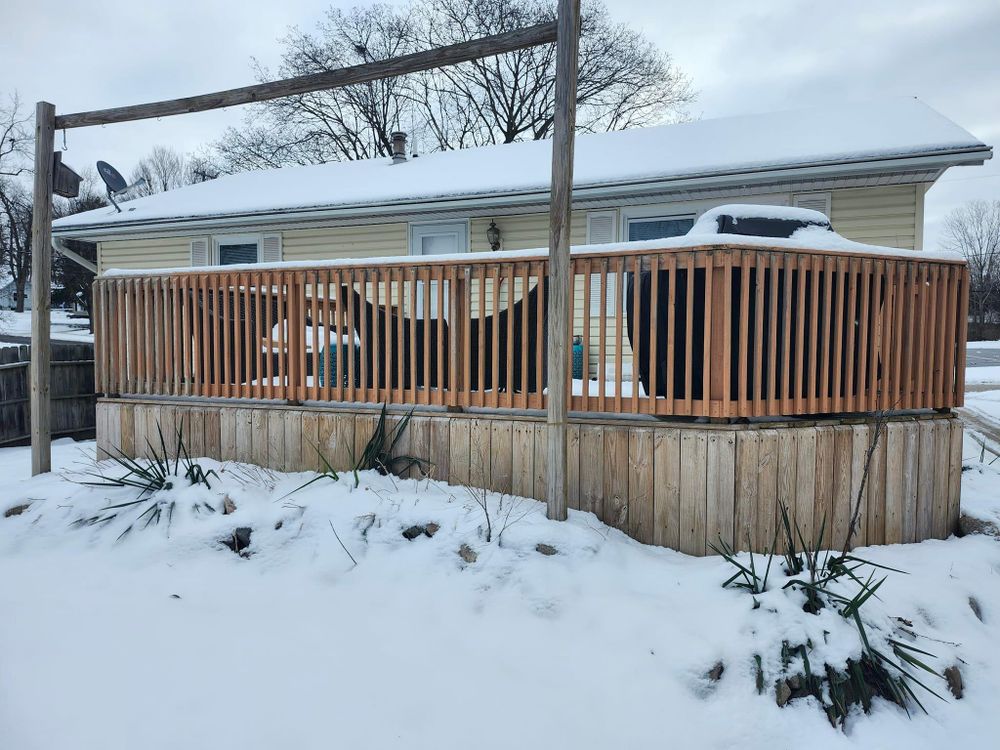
[0,418,1000,750]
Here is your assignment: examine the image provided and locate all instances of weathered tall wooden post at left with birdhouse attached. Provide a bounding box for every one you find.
[30,102,56,475]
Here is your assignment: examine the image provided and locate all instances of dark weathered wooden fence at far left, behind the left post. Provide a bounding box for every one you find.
[0,343,96,445]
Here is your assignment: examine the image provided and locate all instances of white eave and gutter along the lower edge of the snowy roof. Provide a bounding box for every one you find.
[52,144,993,241]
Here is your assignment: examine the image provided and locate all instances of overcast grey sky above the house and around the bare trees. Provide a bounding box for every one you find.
[0,0,1000,253]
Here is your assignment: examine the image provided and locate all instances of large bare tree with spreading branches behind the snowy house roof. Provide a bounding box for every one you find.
[215,0,694,172]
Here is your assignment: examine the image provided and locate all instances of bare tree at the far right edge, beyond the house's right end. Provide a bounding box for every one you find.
[944,200,1000,338]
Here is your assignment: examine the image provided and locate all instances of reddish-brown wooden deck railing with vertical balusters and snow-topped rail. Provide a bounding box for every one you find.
[94,245,968,418]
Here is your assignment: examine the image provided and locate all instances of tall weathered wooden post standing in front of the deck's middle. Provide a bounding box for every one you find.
[546,0,580,521]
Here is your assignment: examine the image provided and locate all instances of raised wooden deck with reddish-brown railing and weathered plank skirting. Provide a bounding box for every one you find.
[94,246,968,555]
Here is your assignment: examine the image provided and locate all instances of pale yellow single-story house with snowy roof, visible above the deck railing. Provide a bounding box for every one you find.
[53,98,992,272]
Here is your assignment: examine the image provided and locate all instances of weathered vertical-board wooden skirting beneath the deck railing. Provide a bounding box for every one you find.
[97,398,962,555]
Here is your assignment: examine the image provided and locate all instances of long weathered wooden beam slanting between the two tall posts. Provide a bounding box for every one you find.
[55,21,556,130]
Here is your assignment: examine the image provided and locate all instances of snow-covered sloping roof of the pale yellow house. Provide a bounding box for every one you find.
[54,98,989,233]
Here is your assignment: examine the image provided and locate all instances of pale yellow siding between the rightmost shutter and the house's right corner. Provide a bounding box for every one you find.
[830,185,924,250]
